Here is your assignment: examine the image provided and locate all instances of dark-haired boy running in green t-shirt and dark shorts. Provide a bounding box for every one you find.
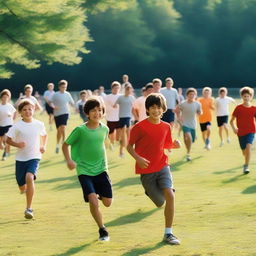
[62,97,112,241]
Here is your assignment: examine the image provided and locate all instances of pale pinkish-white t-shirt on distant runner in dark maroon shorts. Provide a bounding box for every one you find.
[104,93,120,122]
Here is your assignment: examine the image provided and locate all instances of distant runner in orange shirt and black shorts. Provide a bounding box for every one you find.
[198,87,214,150]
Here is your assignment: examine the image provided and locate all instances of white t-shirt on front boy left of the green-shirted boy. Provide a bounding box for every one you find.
[7,119,46,161]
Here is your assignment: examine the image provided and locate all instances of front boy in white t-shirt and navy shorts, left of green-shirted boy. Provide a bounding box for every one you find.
[7,99,47,219]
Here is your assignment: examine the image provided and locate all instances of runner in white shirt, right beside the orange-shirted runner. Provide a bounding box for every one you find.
[215,87,236,147]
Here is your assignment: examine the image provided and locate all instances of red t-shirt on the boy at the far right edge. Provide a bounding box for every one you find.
[233,104,256,136]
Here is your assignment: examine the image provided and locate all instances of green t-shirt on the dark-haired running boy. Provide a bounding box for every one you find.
[65,123,109,176]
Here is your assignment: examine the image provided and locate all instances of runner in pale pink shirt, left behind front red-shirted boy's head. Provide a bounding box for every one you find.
[132,83,153,123]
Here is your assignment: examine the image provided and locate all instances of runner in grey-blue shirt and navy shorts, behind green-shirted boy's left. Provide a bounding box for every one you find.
[51,80,74,154]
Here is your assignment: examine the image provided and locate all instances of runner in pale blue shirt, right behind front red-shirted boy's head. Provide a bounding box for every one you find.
[160,77,180,127]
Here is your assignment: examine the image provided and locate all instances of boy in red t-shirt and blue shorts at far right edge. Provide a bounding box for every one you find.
[230,87,256,174]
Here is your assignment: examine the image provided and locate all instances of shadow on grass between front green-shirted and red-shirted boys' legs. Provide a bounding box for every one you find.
[106,208,158,227]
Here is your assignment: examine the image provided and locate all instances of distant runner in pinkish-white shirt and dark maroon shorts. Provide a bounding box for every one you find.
[104,81,121,150]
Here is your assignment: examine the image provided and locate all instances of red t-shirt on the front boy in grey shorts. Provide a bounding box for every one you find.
[129,119,172,174]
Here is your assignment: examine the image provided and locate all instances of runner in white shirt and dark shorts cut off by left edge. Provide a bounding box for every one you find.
[0,89,16,161]
